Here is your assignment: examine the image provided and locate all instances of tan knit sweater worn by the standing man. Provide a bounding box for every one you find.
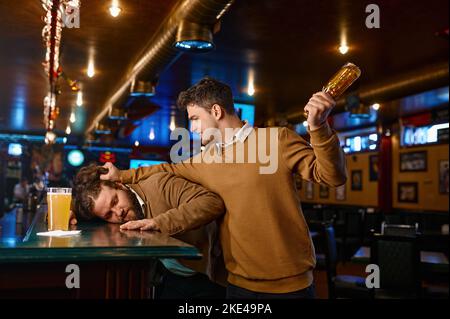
[120,124,347,293]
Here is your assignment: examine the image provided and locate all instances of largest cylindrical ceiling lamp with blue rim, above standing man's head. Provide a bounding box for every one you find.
[173,20,215,53]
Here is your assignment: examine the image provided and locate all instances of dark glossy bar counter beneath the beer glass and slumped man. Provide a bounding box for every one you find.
[0,206,201,299]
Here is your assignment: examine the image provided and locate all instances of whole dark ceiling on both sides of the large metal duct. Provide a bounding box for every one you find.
[0,0,449,139]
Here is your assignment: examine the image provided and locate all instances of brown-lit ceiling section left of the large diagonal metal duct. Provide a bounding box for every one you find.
[0,0,176,131]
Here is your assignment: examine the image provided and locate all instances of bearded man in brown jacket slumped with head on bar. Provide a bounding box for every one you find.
[71,165,226,299]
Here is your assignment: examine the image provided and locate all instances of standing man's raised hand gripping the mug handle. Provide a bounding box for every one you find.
[304,92,336,130]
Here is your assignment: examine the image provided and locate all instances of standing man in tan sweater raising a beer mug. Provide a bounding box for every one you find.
[101,78,347,298]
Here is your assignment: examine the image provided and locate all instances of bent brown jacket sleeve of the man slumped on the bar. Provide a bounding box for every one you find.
[149,174,225,236]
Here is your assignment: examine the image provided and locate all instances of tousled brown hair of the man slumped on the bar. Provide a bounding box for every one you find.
[72,164,119,220]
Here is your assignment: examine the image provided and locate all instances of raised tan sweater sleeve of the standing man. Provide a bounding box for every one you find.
[279,123,347,187]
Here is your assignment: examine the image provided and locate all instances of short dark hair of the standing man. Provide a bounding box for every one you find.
[177,77,234,115]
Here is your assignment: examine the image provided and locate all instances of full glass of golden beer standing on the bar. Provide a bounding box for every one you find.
[47,187,72,231]
